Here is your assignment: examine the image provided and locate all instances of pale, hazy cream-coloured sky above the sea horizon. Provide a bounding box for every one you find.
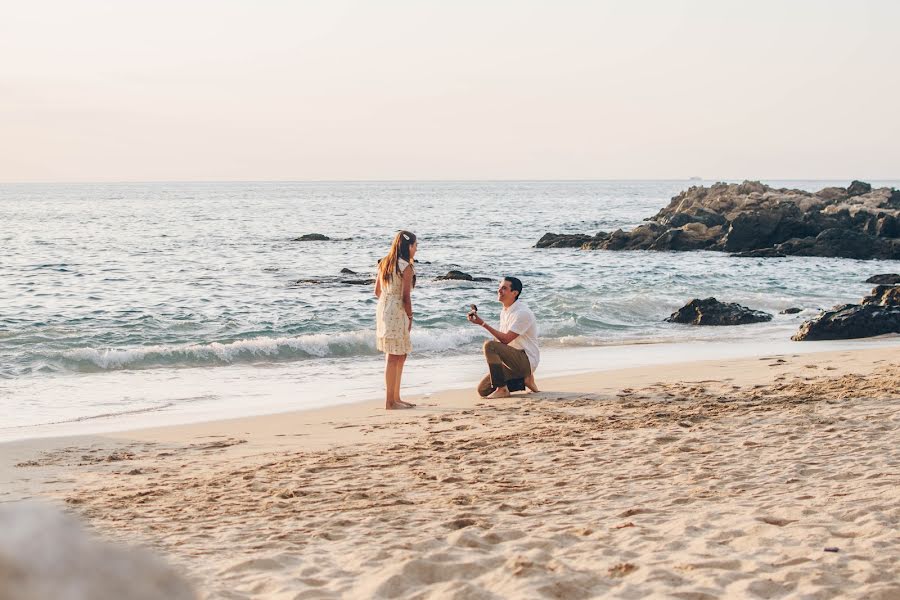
[0,0,900,182]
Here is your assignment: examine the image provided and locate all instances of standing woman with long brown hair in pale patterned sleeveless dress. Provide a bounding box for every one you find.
[375,231,418,410]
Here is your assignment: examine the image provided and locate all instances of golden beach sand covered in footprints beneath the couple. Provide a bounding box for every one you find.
[0,346,900,599]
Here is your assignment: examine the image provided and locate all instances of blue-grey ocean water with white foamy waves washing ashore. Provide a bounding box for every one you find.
[0,181,900,439]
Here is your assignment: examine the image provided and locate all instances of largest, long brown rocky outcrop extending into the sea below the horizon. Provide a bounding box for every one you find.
[548,181,900,259]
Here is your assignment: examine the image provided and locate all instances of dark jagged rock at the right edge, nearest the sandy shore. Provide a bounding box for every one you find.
[791,285,900,342]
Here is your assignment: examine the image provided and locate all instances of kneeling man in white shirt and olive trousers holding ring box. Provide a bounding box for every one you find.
[468,277,541,398]
